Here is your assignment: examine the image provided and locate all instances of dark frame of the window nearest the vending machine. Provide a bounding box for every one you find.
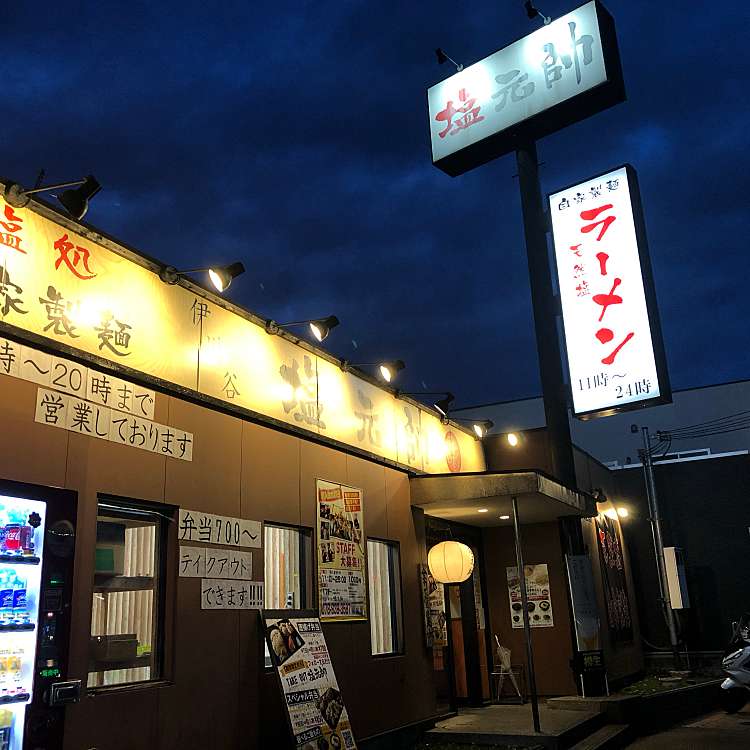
[86,492,179,694]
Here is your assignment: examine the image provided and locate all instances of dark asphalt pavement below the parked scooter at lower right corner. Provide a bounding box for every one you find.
[628,706,750,750]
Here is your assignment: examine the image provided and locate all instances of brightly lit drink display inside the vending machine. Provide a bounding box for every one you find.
[0,495,47,750]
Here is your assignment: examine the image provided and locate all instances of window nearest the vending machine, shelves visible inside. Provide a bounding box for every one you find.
[88,498,173,689]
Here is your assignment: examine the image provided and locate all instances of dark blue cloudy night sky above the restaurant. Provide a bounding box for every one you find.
[0,0,750,406]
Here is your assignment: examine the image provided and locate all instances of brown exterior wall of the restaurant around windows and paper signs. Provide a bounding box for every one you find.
[0,376,434,750]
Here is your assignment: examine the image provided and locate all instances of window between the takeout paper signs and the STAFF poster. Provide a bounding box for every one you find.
[263,523,312,667]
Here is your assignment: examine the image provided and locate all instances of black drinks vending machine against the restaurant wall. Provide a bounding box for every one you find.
[0,481,80,750]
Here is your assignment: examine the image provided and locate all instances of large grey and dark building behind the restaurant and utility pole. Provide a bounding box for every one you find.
[457,380,750,652]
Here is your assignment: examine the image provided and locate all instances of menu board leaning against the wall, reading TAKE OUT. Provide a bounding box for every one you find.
[262,609,357,750]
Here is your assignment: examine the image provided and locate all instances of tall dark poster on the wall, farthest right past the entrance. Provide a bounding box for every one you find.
[596,516,633,643]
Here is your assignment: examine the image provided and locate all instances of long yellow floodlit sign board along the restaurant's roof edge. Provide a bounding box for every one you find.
[0,185,485,473]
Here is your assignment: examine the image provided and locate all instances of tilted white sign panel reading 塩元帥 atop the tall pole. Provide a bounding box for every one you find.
[427,2,608,170]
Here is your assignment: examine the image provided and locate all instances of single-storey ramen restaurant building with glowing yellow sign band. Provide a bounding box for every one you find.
[0,184,642,750]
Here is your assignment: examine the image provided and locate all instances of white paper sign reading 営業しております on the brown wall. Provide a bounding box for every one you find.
[34,388,193,461]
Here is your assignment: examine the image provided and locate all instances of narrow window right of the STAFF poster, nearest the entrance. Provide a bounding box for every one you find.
[367,539,403,656]
